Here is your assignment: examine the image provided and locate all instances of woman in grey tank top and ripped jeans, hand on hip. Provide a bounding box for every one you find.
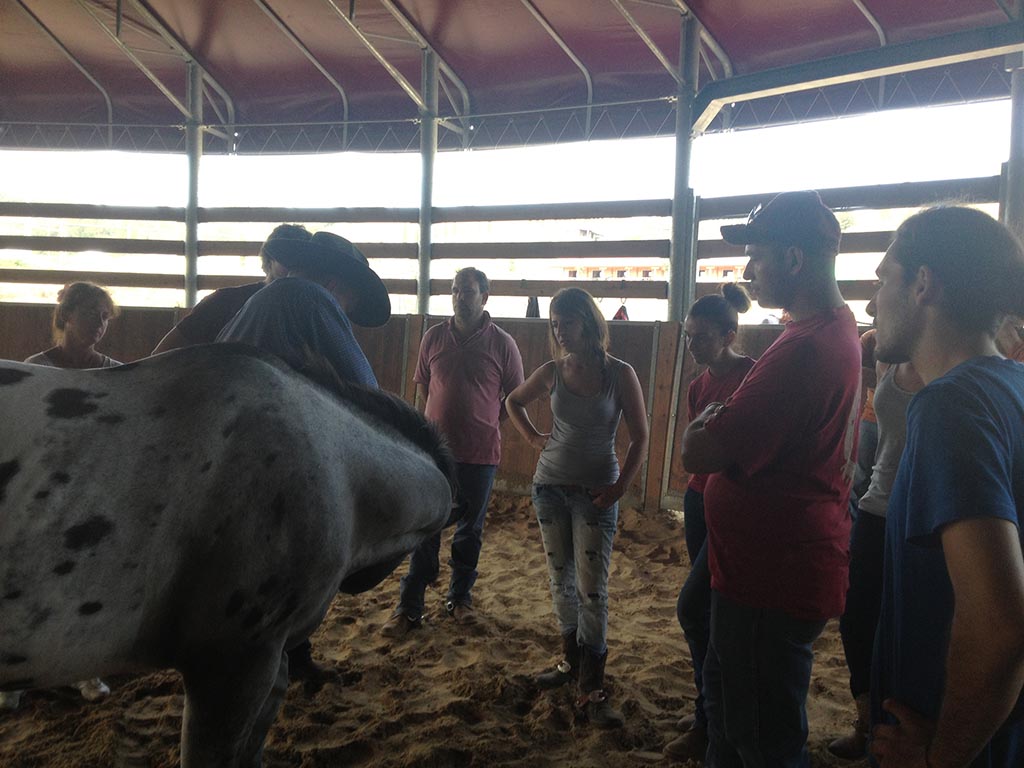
[506,288,647,728]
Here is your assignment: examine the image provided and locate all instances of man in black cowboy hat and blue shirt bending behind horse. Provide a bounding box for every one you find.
[217,231,391,387]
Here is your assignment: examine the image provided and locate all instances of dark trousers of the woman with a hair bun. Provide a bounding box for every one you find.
[676,488,711,728]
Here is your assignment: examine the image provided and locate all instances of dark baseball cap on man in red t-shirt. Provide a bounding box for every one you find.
[722,189,840,253]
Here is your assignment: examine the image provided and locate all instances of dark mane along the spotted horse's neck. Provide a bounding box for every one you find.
[299,346,458,498]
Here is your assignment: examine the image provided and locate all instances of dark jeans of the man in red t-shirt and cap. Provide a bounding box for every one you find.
[703,591,825,768]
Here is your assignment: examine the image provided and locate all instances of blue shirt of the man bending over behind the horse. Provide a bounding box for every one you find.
[217,278,379,389]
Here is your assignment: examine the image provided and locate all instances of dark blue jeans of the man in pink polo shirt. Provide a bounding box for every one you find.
[398,463,498,616]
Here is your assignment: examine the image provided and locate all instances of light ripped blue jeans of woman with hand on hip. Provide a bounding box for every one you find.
[534,485,618,655]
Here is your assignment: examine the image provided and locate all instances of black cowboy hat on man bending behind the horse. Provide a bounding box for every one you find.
[263,231,391,328]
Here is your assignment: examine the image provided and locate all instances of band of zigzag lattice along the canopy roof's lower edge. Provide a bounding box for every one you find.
[0,58,1011,155]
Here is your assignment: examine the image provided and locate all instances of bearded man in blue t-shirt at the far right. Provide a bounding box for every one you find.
[870,206,1024,768]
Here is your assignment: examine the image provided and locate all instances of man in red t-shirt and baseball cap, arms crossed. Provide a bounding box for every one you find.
[683,191,861,768]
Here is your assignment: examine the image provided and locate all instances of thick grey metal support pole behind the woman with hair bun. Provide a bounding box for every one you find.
[669,13,700,322]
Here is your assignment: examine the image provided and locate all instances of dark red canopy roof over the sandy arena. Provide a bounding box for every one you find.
[0,0,1020,152]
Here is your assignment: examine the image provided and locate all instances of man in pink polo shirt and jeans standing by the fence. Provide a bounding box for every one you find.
[381,267,523,638]
